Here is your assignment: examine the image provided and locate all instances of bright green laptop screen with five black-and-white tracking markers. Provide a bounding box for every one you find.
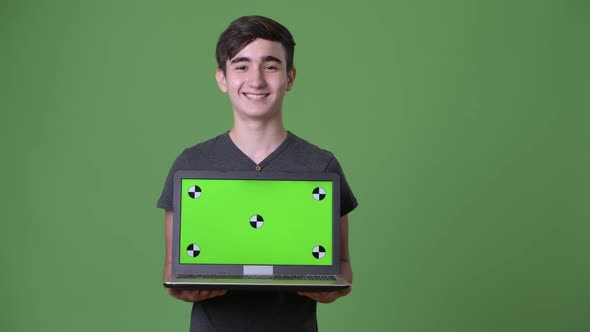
[179,179,332,265]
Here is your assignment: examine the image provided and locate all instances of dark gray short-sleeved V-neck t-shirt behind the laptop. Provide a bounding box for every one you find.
[157,132,358,332]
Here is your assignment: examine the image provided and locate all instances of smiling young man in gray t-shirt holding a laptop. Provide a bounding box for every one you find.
[158,16,358,332]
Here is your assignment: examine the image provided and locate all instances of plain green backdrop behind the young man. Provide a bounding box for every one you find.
[0,0,590,332]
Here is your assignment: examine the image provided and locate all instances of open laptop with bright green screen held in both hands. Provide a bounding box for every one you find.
[164,171,350,291]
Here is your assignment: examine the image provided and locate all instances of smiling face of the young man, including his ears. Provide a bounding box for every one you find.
[215,38,295,118]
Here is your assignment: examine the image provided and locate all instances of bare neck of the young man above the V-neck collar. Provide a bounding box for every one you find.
[229,117,287,164]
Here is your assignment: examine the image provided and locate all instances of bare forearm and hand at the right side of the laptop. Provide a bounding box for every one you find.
[297,215,352,303]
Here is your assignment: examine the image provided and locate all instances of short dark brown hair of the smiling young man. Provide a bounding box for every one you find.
[215,16,295,73]
